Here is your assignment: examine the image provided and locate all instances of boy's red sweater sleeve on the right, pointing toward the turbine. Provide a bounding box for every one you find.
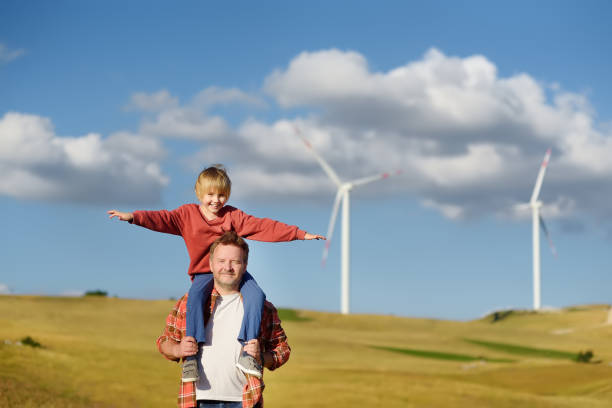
[231,209,306,242]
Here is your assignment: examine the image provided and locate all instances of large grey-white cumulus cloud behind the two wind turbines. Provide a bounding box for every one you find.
[192,49,612,226]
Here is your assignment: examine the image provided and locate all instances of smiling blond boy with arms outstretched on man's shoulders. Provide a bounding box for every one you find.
[108,165,325,382]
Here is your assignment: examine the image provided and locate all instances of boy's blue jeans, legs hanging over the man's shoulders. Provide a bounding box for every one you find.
[186,271,266,359]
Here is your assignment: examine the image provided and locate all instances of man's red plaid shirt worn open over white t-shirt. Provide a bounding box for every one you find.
[157,289,291,408]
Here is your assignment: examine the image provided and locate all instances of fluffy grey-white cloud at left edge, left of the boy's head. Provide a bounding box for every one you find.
[0,112,168,204]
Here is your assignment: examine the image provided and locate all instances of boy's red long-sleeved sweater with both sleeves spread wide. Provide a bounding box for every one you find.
[132,204,306,280]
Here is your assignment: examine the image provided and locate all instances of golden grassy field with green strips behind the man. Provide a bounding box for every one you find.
[0,296,612,408]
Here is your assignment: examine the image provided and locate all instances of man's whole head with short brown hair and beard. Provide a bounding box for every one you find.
[210,231,249,295]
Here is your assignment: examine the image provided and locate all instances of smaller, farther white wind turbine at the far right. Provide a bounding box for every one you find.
[529,149,557,310]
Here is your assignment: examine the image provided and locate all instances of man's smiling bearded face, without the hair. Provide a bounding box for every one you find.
[210,245,246,291]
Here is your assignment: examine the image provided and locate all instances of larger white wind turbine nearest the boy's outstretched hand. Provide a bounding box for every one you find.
[295,127,400,314]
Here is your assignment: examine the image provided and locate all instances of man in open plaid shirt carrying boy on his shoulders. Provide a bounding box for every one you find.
[157,232,291,408]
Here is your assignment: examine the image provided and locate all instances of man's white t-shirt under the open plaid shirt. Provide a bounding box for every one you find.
[196,293,246,401]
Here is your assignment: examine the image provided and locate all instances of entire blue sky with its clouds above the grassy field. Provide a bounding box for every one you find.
[0,0,612,319]
